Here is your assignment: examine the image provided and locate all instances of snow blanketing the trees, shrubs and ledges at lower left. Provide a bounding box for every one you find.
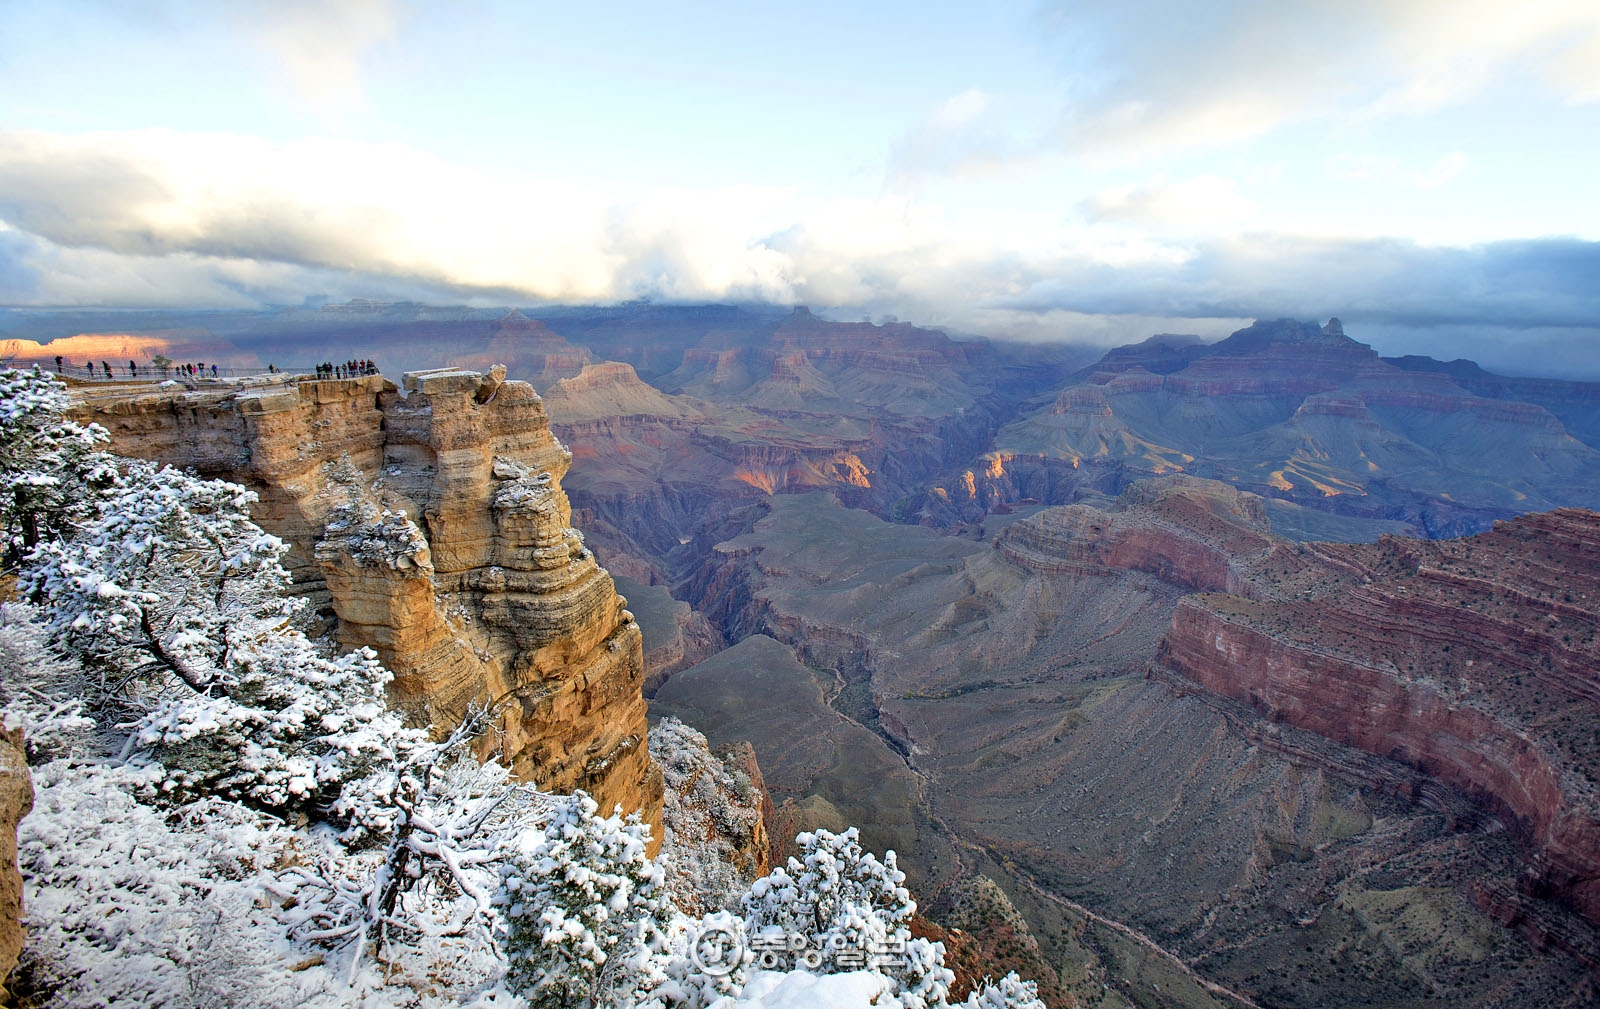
[0,369,1040,1009]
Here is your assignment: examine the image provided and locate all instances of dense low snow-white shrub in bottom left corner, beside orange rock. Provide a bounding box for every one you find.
[18,761,331,1007]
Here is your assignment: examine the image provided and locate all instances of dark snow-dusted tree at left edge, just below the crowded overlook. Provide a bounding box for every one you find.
[0,366,115,568]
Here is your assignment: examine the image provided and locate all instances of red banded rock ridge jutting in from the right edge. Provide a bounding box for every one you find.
[1158,508,1600,919]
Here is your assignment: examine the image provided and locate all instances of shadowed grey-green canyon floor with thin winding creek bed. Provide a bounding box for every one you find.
[656,481,1597,1006]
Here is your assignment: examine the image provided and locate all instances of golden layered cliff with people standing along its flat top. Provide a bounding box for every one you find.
[77,368,661,835]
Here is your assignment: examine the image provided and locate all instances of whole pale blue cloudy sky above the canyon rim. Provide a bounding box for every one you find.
[0,0,1600,377]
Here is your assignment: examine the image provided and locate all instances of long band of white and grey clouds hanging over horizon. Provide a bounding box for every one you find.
[0,131,1600,375]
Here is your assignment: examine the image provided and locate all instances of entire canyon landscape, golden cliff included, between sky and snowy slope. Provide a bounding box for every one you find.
[8,302,1600,1006]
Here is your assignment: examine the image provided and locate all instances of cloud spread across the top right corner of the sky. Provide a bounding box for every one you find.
[1045,0,1600,157]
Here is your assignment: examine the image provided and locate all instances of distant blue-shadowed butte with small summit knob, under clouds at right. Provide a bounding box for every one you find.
[947,320,1600,539]
